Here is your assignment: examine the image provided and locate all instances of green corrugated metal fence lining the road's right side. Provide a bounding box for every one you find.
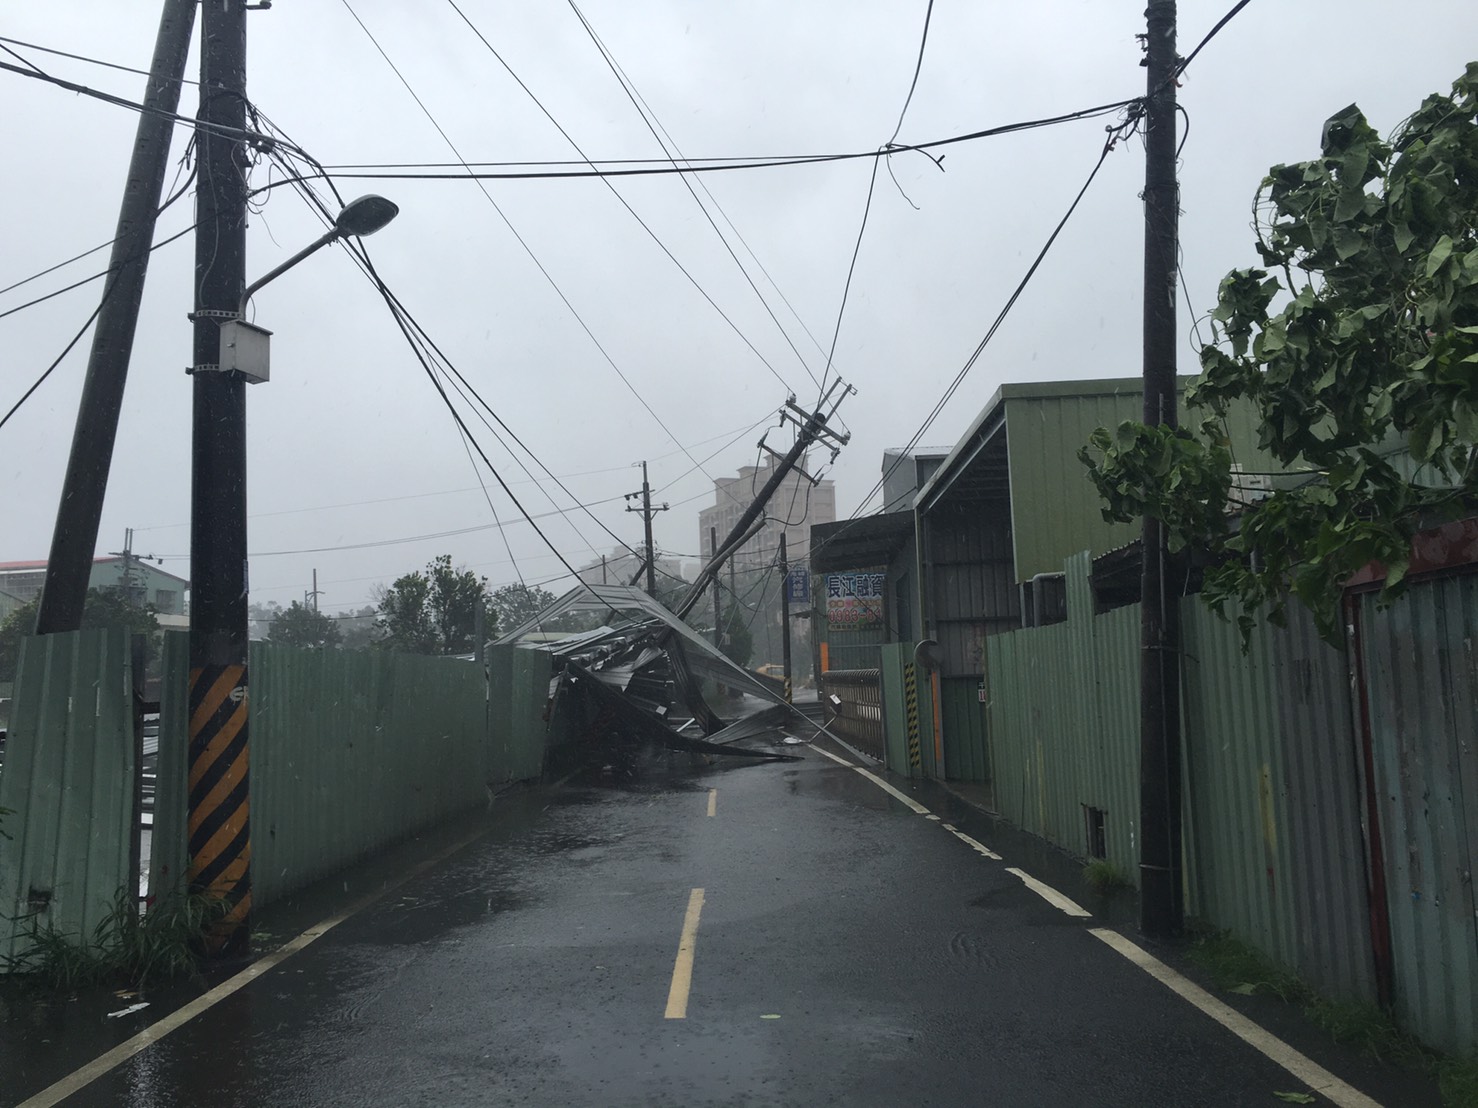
[987,555,1460,1050]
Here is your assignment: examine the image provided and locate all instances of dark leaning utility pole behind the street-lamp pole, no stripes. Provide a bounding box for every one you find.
[35,0,195,635]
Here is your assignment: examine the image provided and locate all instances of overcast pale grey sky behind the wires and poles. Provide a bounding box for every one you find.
[0,0,1478,610]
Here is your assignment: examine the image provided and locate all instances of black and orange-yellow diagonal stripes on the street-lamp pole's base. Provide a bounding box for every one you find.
[189,665,251,956]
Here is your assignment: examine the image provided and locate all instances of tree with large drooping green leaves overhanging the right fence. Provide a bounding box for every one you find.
[1079,62,1478,640]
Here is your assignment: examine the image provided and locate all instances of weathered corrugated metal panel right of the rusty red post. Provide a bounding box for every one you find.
[1358,573,1478,1053]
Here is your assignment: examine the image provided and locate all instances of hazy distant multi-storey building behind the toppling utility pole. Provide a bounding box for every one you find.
[698,461,837,569]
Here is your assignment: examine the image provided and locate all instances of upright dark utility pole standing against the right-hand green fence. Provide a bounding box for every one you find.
[1140,0,1184,938]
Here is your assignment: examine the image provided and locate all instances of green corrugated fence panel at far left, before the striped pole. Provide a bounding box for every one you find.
[0,628,137,957]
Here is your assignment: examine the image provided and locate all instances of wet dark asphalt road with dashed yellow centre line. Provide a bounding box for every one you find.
[0,748,1412,1107]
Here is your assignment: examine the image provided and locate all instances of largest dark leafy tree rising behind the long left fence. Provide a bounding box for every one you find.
[377,554,498,654]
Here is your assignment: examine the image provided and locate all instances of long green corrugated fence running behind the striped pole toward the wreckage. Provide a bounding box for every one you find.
[151,635,548,907]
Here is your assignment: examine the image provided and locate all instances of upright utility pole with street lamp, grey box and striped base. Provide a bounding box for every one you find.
[188,0,251,956]
